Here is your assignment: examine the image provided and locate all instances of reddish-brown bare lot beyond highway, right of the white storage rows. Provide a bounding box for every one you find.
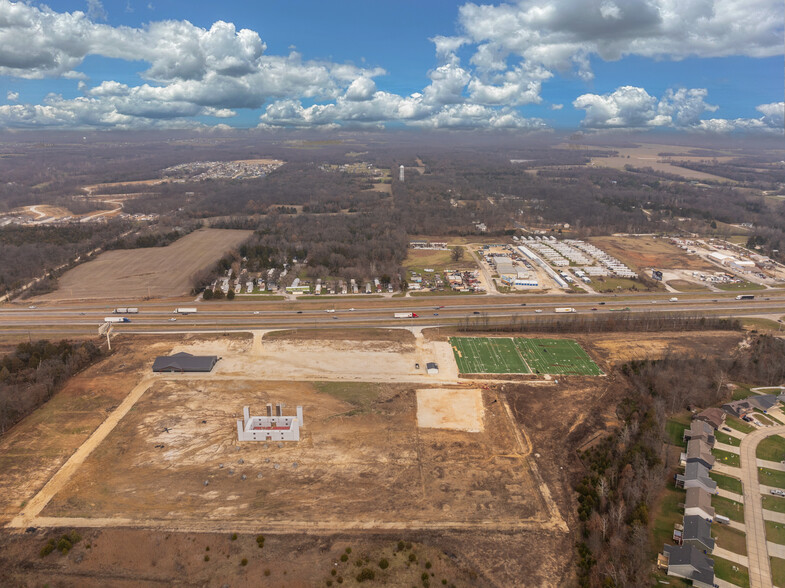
[589,237,716,271]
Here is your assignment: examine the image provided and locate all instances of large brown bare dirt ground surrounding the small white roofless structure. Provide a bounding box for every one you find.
[0,332,573,586]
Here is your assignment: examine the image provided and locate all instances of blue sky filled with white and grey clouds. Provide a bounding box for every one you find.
[0,0,785,134]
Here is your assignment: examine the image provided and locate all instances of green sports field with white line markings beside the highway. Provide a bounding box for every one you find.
[450,337,602,376]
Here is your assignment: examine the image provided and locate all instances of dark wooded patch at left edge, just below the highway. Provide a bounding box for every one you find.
[0,340,102,434]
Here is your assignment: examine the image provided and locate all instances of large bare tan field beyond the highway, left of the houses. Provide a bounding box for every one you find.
[39,229,251,300]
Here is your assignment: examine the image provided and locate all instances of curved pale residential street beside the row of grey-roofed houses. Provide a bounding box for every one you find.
[740,425,785,588]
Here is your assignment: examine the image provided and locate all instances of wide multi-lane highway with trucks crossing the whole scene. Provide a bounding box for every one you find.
[0,290,785,334]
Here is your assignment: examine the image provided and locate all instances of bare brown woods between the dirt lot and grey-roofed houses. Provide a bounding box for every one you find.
[576,335,785,588]
